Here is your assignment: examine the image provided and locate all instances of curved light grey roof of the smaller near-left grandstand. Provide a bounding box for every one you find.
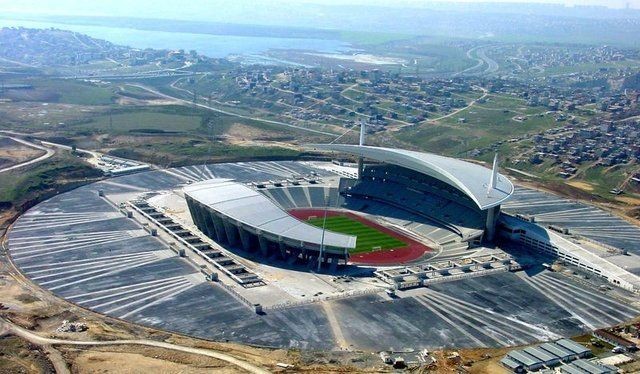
[184,179,356,248]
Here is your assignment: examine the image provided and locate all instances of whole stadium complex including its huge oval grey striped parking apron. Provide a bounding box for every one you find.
[7,135,640,352]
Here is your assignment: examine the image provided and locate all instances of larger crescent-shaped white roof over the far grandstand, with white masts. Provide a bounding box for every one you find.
[310,144,514,210]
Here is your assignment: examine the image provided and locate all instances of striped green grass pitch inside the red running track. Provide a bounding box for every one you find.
[307,216,407,254]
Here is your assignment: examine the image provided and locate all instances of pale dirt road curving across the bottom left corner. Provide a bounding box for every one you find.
[0,318,269,374]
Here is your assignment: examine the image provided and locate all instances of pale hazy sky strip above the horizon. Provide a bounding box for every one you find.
[0,0,640,19]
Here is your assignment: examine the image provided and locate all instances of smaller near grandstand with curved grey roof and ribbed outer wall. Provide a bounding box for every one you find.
[184,179,356,262]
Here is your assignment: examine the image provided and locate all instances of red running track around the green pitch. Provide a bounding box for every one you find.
[289,209,433,265]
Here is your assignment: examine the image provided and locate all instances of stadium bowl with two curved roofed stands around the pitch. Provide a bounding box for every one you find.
[184,141,513,265]
